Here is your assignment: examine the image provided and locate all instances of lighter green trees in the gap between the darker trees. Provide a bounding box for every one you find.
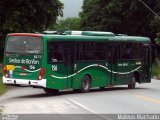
[52,17,80,31]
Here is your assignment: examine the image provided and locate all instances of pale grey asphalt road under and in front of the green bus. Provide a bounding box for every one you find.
[0,80,160,120]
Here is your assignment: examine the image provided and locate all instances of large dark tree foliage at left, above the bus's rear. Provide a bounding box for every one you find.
[0,0,63,34]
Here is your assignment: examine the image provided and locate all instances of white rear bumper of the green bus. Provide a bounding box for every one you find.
[3,76,46,87]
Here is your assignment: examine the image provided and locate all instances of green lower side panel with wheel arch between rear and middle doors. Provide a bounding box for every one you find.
[73,61,109,88]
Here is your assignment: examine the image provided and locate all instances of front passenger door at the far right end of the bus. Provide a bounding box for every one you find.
[142,45,151,82]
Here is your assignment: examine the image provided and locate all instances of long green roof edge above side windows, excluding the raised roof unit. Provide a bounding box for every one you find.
[44,35,151,43]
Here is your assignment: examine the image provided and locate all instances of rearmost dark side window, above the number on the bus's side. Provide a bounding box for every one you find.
[48,41,63,63]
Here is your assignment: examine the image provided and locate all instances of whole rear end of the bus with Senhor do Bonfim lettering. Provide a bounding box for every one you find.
[3,33,46,87]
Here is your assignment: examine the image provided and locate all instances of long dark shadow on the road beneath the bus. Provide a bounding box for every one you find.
[12,87,148,99]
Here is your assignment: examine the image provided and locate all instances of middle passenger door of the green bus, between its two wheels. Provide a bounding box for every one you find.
[108,46,117,85]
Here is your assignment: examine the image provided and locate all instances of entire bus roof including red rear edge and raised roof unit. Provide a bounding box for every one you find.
[8,31,151,43]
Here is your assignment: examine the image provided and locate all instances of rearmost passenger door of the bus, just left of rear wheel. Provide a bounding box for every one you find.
[63,42,74,88]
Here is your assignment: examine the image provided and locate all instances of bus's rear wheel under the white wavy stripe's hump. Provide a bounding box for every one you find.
[80,75,91,93]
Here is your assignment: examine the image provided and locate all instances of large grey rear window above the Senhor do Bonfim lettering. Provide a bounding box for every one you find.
[6,36,43,54]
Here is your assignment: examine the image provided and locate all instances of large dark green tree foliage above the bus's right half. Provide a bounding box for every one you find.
[80,0,160,37]
